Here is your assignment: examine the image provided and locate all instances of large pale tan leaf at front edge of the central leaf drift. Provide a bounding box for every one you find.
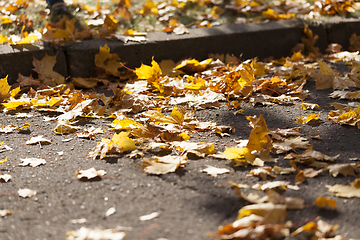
[141,155,186,175]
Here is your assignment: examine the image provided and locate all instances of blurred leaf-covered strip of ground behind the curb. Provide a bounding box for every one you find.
[0,0,360,44]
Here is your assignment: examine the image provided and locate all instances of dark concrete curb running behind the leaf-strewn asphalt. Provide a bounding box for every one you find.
[0,17,360,84]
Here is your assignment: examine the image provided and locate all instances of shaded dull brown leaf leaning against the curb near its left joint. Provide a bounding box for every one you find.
[33,54,65,86]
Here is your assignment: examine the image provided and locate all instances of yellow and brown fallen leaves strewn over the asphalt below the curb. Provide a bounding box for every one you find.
[0,23,360,240]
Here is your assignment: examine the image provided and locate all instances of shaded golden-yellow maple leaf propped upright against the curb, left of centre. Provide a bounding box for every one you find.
[95,44,123,76]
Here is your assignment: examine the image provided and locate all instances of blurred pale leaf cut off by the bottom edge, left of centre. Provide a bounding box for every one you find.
[66,227,126,240]
